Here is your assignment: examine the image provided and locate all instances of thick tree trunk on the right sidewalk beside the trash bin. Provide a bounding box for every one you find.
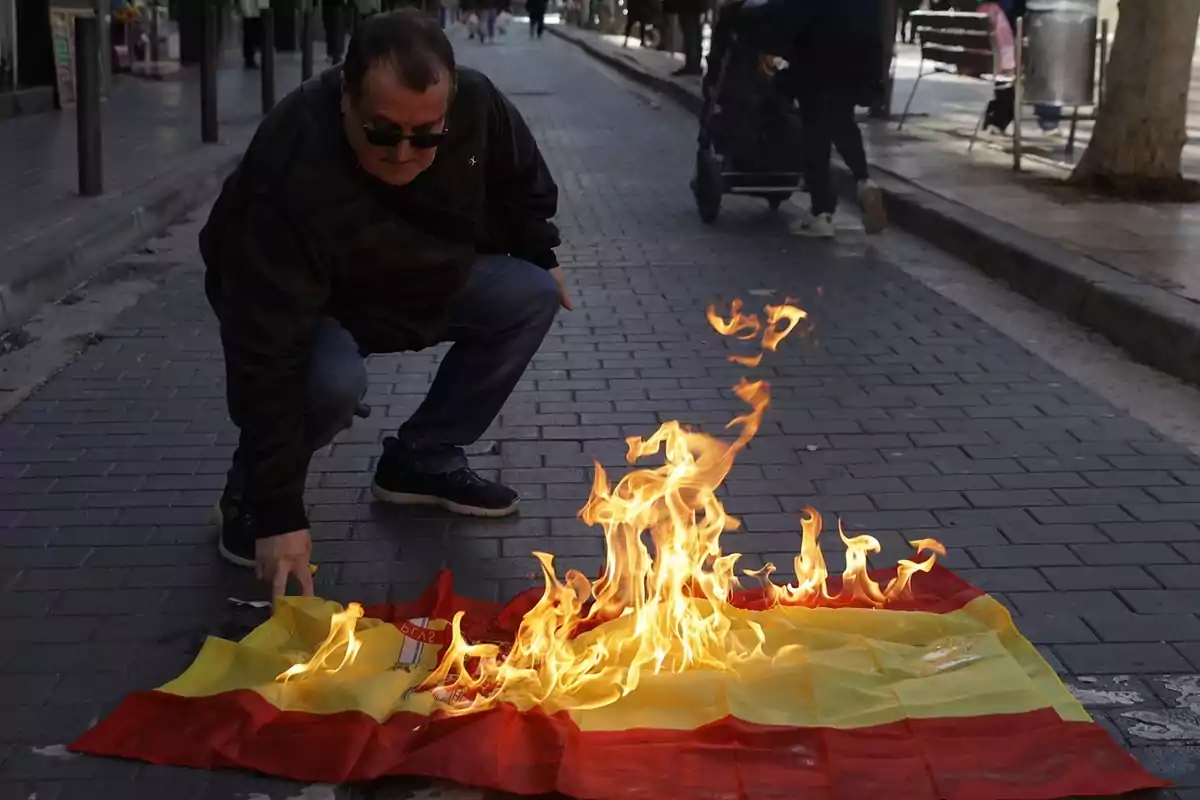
[1072,0,1200,191]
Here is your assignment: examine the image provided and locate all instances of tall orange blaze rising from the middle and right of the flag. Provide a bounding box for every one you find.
[422,301,944,714]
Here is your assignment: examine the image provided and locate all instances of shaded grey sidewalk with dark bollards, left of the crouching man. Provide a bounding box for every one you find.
[0,47,324,330]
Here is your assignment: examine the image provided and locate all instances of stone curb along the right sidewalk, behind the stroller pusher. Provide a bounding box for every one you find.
[546,25,1200,384]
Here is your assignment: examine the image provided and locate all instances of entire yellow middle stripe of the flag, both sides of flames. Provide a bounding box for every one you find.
[161,596,1090,732]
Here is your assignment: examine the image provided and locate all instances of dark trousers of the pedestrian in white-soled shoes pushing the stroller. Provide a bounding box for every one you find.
[797,80,869,216]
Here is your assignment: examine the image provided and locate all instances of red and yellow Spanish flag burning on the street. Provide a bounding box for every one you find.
[72,566,1165,800]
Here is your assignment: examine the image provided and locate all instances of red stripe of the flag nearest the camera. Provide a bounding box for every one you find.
[71,691,1166,800]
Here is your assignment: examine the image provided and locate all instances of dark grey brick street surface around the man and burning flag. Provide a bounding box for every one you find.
[0,21,1200,800]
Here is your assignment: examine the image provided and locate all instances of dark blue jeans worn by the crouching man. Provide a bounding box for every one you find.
[307,255,559,474]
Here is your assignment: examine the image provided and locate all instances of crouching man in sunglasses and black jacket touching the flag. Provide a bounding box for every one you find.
[200,10,570,595]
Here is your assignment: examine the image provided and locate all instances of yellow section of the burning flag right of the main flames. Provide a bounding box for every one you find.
[571,596,1090,730]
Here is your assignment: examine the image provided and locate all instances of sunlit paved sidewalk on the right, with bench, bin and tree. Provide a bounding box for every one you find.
[552,25,1200,381]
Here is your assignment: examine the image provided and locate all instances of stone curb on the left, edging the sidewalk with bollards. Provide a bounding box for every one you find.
[0,142,244,330]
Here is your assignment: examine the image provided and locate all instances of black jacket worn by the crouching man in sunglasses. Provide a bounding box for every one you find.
[200,68,559,536]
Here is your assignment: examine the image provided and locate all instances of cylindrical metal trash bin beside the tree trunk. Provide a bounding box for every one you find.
[1022,0,1099,106]
